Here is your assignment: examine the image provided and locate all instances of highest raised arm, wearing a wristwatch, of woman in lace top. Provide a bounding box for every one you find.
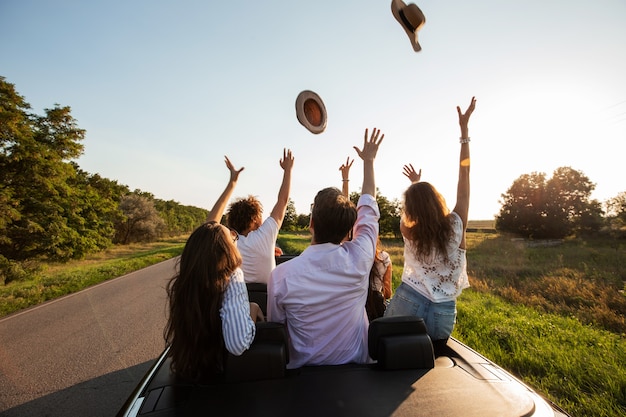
[454,97,476,249]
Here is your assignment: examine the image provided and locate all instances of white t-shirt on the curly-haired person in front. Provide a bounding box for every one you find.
[237,217,279,284]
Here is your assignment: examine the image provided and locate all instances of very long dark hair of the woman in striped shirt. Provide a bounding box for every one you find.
[164,222,241,382]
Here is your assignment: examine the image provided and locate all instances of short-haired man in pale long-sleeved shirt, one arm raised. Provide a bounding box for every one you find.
[267,129,384,369]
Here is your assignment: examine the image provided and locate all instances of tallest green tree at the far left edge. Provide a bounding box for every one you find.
[0,78,94,261]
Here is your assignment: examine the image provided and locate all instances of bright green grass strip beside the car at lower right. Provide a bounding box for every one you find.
[452,289,626,417]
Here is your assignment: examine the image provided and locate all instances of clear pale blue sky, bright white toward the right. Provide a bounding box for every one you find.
[0,0,626,220]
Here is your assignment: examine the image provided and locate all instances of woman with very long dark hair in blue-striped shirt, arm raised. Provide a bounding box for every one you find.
[164,158,263,382]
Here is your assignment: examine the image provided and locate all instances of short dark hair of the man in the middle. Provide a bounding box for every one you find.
[311,187,357,244]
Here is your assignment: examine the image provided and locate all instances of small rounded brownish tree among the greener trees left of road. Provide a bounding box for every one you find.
[115,193,165,244]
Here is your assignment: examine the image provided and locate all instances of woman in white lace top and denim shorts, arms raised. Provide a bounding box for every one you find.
[385,97,476,344]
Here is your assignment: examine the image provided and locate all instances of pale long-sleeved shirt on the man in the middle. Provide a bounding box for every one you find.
[267,194,380,369]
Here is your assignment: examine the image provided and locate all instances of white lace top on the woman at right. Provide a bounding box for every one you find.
[402,212,469,303]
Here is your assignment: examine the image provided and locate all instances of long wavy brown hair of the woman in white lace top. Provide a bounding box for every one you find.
[403,181,452,261]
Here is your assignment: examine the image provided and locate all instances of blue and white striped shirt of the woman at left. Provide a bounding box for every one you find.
[220,268,256,356]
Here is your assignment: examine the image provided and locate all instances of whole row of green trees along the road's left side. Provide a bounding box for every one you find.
[0,77,207,282]
